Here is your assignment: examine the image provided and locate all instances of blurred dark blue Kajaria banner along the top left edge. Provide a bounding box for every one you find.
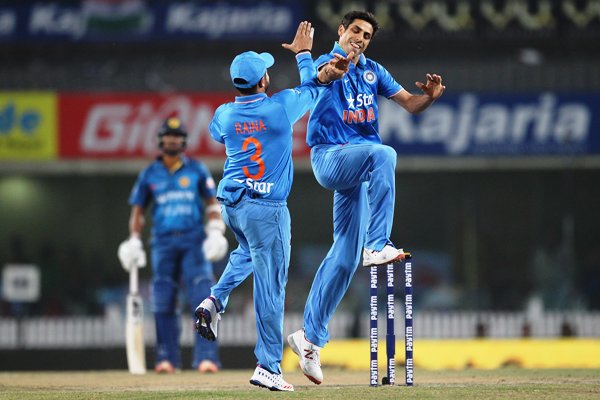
[0,0,305,41]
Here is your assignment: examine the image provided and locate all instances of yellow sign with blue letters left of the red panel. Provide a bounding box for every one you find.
[0,92,58,161]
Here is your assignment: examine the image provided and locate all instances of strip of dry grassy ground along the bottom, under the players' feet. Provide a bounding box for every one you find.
[0,368,600,400]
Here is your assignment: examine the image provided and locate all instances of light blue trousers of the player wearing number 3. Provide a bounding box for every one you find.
[211,196,291,374]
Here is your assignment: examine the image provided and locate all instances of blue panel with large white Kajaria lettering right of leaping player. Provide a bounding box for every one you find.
[379,93,600,156]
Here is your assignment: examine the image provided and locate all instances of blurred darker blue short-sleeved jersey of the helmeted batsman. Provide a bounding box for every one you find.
[129,155,215,236]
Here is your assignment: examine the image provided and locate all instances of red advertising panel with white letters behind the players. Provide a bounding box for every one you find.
[59,93,309,159]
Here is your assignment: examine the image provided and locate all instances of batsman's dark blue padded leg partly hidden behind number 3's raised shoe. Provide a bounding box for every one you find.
[182,235,221,372]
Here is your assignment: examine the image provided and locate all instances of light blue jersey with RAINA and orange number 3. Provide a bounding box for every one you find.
[209,53,322,204]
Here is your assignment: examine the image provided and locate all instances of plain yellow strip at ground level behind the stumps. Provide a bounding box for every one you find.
[281,338,600,372]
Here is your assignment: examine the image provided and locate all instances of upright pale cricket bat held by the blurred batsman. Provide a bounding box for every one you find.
[125,262,146,375]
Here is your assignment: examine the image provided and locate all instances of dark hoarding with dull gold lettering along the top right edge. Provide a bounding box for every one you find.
[307,0,600,41]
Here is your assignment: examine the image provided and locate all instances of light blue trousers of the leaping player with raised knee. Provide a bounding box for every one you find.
[304,143,397,347]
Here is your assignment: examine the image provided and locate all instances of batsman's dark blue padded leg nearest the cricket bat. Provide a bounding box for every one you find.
[151,238,181,372]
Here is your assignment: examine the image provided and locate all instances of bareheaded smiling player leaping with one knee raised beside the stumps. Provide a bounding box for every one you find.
[288,11,445,384]
